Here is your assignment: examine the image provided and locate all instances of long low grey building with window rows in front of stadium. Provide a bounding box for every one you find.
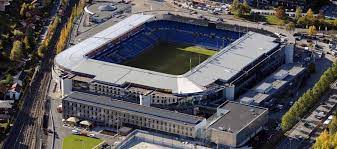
[62,92,206,138]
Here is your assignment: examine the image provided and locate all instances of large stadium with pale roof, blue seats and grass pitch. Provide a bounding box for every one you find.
[53,14,287,104]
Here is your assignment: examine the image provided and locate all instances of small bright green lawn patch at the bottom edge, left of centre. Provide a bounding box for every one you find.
[62,135,102,149]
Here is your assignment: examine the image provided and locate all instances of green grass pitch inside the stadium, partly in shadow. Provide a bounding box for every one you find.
[124,43,216,75]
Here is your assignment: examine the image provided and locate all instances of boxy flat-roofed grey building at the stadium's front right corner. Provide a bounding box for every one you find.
[206,101,268,147]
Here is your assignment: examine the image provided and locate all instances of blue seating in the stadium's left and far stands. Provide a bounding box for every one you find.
[92,20,240,63]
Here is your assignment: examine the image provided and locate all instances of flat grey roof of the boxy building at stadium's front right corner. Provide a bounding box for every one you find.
[209,101,268,133]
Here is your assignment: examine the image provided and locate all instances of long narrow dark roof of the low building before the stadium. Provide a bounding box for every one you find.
[63,92,205,125]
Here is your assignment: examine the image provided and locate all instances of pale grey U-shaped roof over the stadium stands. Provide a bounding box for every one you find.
[55,14,278,94]
